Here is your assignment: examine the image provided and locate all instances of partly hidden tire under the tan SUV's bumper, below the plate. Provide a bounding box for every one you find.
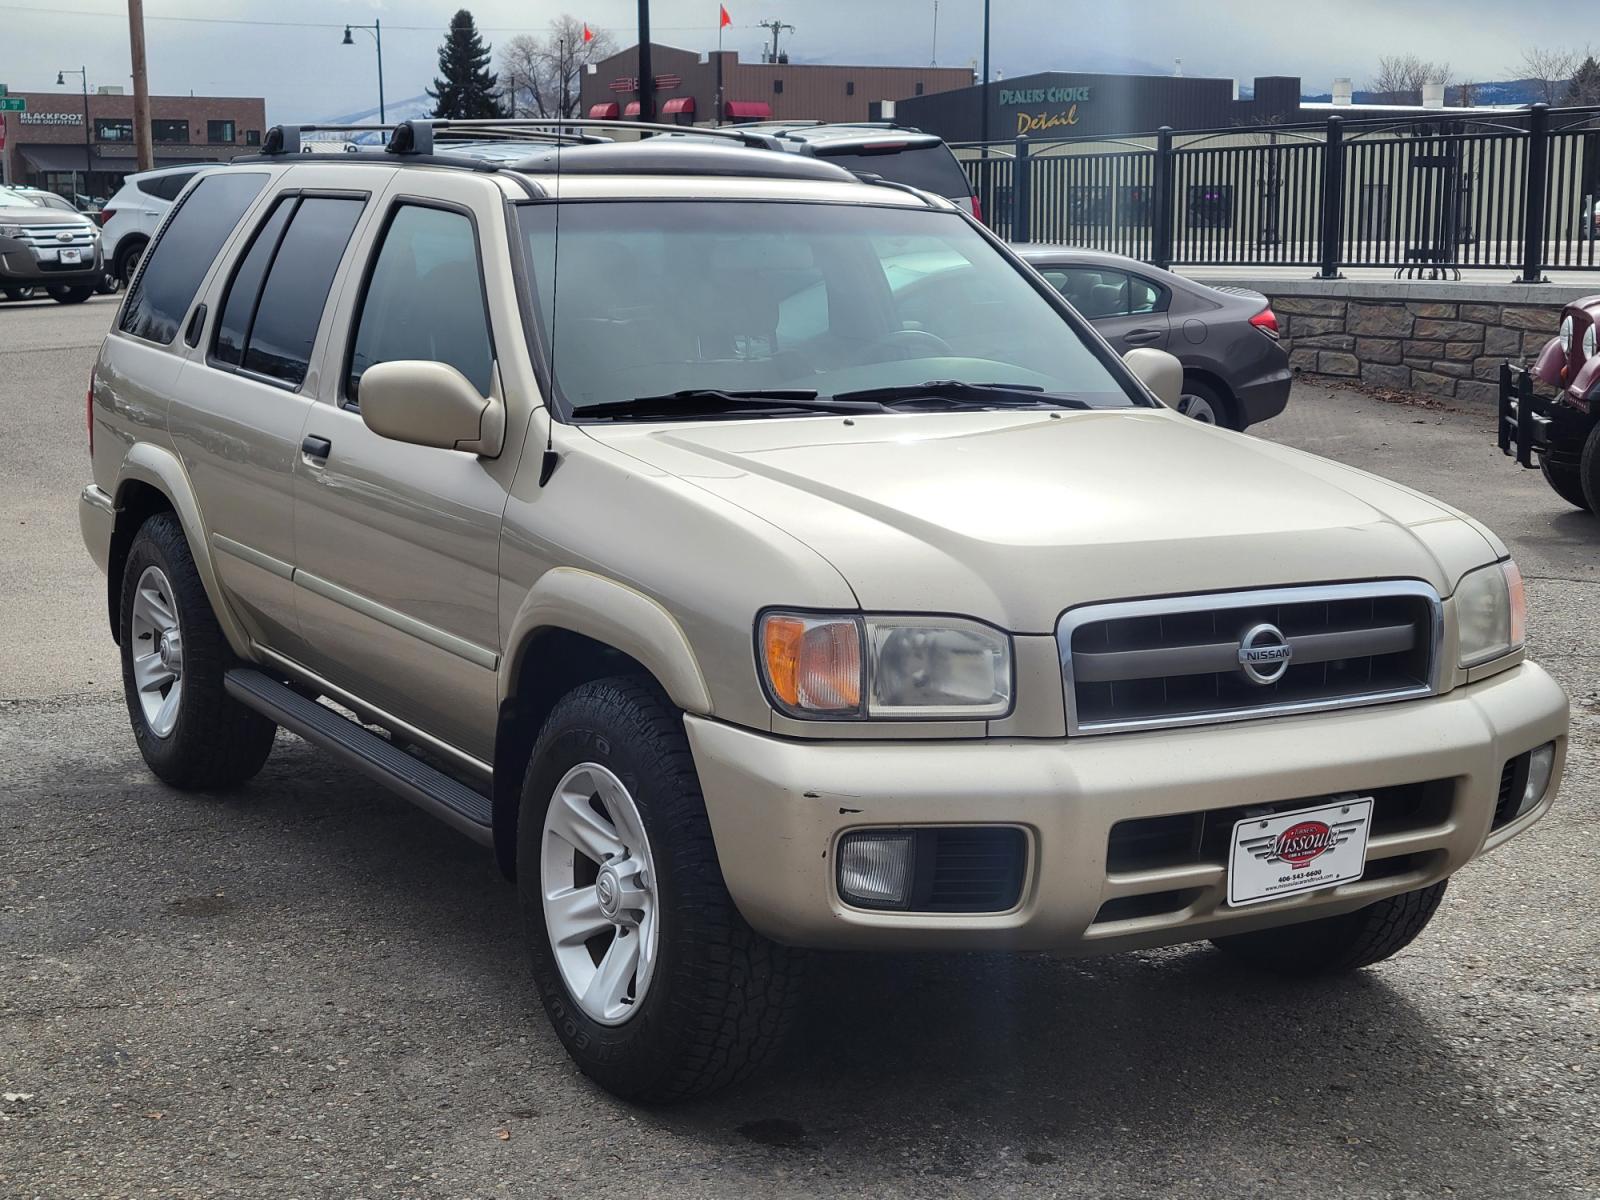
[1211,880,1446,978]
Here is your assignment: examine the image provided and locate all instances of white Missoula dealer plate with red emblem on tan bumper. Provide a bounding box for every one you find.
[1227,795,1373,907]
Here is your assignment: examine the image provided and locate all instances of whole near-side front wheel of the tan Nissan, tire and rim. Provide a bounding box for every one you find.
[517,678,803,1104]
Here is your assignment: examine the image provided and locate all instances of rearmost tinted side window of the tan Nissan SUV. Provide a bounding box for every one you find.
[120,171,267,346]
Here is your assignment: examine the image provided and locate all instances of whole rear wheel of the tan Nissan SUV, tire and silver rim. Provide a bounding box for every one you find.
[118,512,277,789]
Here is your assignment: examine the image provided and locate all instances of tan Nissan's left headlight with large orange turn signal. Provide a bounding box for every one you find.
[757,613,1011,720]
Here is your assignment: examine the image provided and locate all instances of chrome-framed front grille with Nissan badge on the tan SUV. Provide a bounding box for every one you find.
[1056,579,1443,733]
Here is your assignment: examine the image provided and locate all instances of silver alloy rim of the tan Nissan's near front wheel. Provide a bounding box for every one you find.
[539,763,659,1026]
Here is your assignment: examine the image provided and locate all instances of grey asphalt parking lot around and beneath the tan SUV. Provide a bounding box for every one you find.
[0,301,1600,1200]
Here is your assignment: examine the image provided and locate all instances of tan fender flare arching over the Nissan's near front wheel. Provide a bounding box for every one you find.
[499,566,712,717]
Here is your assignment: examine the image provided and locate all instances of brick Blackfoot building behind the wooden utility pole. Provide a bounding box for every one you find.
[0,88,267,197]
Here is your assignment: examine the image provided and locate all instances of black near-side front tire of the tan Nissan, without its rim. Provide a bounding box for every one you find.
[517,677,805,1104]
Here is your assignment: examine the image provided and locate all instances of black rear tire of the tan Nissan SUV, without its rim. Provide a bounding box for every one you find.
[117,512,277,789]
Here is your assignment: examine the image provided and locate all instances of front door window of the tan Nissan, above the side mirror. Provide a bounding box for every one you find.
[344,205,494,400]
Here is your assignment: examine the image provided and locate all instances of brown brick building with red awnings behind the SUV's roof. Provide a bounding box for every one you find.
[582,42,973,125]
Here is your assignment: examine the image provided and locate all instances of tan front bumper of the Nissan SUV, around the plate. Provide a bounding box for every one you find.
[685,662,1568,954]
